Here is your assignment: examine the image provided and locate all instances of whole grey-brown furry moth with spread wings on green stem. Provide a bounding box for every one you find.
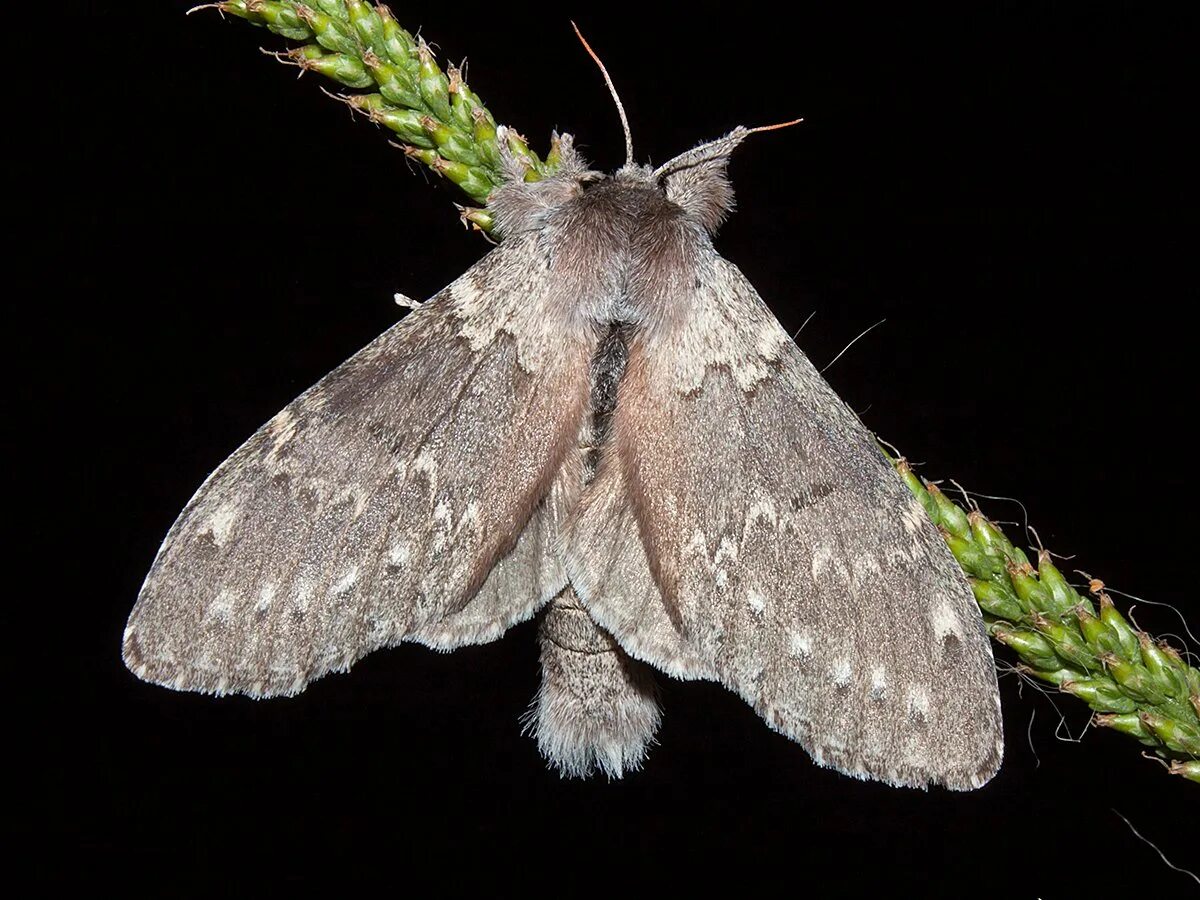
[124,33,1002,790]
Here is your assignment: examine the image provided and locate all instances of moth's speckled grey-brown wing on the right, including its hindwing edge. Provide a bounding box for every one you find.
[566,226,1001,788]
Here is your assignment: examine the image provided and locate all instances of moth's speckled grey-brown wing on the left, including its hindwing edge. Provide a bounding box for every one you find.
[125,234,594,696]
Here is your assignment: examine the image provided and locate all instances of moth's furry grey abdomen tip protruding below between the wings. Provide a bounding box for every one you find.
[526,586,662,779]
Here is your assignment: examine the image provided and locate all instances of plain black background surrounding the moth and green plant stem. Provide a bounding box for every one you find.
[37,2,1200,898]
